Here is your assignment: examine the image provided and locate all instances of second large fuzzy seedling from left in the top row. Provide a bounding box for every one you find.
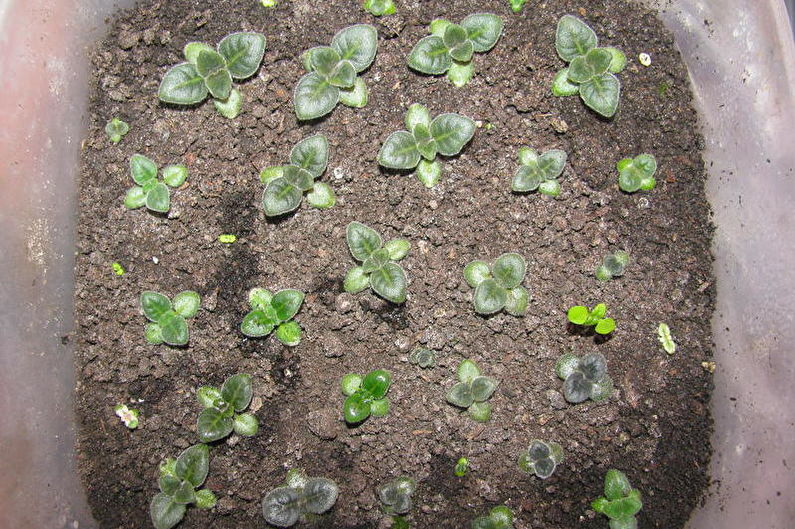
[293,24,378,121]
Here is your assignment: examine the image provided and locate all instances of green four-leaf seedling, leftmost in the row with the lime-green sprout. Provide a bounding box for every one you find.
[141,290,201,345]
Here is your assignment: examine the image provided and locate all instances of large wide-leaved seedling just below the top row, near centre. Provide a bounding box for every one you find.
[378,103,475,188]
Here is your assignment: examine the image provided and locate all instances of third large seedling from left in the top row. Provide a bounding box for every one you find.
[408,13,503,87]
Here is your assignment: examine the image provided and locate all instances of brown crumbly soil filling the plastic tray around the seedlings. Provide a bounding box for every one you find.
[76,0,715,529]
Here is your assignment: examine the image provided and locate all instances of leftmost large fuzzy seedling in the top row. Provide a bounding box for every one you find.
[158,32,265,119]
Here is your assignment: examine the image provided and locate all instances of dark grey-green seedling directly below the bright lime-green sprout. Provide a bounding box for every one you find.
[555,353,613,404]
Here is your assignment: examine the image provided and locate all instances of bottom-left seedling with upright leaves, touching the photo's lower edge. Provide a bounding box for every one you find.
[149,444,216,529]
